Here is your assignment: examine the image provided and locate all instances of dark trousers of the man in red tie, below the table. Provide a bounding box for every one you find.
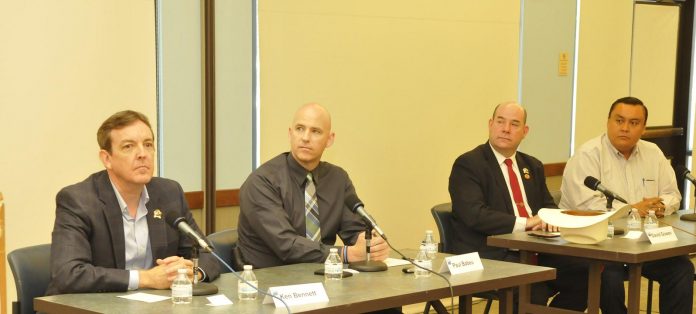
[504,251,589,313]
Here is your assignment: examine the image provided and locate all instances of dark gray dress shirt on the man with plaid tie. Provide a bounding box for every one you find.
[237,152,365,268]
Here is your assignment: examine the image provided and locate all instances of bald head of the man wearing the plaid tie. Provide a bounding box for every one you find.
[288,103,334,171]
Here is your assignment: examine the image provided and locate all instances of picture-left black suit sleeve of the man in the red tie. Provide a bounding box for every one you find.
[449,156,515,235]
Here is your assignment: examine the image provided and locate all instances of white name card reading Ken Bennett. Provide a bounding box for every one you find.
[263,282,329,307]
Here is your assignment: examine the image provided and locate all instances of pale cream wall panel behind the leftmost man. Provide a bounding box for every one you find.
[0,0,156,309]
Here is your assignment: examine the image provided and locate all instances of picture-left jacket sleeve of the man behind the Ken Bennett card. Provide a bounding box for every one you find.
[48,190,129,294]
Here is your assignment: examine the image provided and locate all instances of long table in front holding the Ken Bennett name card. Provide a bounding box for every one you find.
[34,251,556,313]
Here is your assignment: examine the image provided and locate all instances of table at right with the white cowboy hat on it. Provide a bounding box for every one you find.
[487,215,696,313]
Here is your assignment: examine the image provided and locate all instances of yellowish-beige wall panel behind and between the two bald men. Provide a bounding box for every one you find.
[259,0,519,248]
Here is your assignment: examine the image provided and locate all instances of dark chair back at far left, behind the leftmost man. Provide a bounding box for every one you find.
[7,244,51,314]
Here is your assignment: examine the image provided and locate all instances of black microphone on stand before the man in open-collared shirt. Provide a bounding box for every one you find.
[164,212,218,295]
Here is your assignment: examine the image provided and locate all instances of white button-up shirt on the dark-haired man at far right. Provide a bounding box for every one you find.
[559,134,681,215]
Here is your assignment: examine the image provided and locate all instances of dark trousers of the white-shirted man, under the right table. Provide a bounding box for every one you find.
[599,256,694,314]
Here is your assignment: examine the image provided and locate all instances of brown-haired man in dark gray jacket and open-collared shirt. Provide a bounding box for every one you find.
[46,111,219,295]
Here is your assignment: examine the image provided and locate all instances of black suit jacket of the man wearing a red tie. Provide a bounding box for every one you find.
[449,143,556,259]
